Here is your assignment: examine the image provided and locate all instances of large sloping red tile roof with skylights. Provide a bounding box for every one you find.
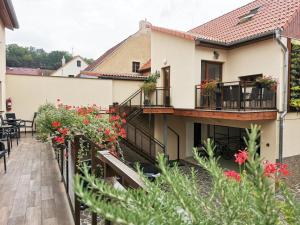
[188,0,300,44]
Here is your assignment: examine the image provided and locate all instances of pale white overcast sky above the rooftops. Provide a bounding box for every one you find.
[7,0,252,58]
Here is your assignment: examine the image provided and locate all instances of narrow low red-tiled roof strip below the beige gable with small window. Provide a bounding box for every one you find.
[80,71,146,80]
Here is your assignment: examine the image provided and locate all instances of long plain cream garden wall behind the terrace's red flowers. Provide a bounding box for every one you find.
[6,75,141,119]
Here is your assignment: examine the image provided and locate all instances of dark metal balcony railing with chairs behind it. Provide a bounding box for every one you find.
[195,81,276,111]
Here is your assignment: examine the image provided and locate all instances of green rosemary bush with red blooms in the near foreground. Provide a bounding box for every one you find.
[75,125,300,225]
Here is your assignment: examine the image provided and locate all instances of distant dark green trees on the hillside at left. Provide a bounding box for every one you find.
[6,44,93,70]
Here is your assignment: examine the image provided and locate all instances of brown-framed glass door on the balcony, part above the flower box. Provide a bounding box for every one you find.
[201,61,222,81]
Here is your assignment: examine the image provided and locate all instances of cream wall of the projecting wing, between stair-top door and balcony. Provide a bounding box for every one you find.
[151,32,195,108]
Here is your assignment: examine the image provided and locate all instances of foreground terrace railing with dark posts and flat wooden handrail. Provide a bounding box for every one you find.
[54,135,144,225]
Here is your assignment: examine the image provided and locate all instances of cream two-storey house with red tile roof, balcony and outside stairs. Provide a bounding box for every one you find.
[114,0,300,185]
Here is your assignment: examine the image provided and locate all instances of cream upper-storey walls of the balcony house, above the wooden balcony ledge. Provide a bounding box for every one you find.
[151,31,286,109]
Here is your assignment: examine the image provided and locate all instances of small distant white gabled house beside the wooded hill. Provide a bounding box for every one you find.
[50,56,88,77]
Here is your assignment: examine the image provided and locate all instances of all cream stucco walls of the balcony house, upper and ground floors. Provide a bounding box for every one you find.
[151,27,300,174]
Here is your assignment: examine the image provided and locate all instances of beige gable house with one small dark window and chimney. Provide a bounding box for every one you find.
[81,20,151,77]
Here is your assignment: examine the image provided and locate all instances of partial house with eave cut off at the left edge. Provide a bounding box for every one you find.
[0,0,19,111]
